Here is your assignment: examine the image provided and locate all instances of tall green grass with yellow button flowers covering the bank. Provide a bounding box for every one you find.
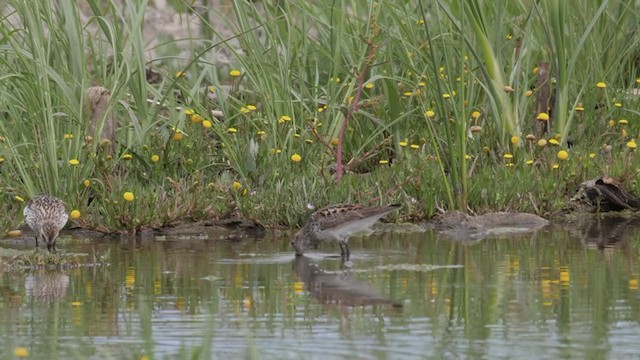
[0,0,640,232]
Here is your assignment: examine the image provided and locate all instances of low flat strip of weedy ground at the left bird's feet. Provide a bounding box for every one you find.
[0,249,110,271]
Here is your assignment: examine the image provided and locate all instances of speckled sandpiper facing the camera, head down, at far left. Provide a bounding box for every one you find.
[24,195,69,252]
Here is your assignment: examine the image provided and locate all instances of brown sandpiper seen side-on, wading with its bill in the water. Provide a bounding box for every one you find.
[291,204,400,259]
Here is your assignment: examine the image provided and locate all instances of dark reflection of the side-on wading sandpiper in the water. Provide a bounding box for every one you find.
[293,256,402,308]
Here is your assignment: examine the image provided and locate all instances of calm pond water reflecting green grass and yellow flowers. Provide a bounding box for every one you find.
[0,219,640,359]
